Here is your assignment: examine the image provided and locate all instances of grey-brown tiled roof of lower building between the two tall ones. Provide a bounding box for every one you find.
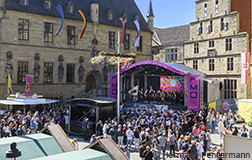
[154,25,190,45]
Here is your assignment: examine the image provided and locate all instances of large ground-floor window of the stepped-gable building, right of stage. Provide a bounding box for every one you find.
[224,79,237,99]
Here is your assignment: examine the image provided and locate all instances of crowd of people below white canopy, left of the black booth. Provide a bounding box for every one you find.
[0,106,69,138]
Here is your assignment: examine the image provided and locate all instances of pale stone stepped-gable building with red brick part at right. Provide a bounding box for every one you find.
[154,0,251,99]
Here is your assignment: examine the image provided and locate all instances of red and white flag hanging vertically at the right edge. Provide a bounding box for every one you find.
[241,53,250,84]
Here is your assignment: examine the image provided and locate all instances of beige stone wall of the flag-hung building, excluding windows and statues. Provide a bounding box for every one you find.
[0,10,152,99]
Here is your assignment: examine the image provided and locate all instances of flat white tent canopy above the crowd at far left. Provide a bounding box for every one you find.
[0,97,58,106]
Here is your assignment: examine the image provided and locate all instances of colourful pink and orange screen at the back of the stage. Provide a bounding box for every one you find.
[160,76,185,92]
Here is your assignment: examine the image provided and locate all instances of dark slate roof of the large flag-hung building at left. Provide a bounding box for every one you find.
[6,0,151,32]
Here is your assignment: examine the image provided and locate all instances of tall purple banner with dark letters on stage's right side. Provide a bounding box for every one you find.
[187,75,200,110]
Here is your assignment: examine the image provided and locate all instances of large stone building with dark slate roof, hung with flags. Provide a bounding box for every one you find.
[0,0,154,101]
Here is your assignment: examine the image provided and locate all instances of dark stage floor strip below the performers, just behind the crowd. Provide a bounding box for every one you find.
[122,102,187,112]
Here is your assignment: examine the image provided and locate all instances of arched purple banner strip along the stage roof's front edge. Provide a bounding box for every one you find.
[120,61,186,75]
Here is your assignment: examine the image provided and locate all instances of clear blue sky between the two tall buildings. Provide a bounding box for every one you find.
[135,0,196,28]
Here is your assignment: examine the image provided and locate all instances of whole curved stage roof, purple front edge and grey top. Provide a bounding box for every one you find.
[120,61,205,77]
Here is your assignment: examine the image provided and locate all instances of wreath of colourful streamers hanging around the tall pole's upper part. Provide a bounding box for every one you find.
[89,52,134,69]
